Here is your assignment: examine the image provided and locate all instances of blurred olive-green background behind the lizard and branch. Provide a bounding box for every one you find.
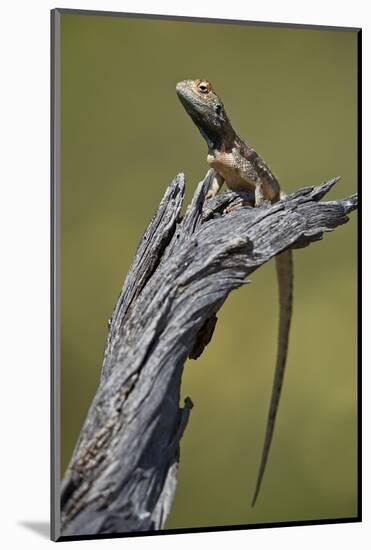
[61,14,357,528]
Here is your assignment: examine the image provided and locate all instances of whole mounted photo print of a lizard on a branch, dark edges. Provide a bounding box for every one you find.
[51,9,361,540]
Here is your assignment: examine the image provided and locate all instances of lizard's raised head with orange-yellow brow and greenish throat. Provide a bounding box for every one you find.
[176,80,230,148]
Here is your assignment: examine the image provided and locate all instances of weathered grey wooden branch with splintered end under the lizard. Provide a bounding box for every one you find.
[61,172,357,536]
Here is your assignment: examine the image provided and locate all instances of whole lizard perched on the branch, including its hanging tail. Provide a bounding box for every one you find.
[176,80,293,506]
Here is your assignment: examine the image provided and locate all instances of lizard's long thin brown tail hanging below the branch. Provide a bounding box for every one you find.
[251,250,294,506]
